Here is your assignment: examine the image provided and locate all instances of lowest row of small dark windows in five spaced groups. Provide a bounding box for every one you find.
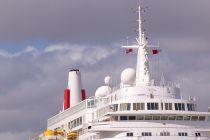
[126,132,201,137]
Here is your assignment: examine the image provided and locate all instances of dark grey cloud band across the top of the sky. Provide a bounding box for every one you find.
[0,0,210,44]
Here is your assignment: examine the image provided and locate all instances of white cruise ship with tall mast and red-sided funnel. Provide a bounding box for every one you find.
[32,3,210,140]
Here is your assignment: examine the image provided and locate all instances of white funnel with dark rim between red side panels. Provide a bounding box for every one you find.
[68,69,82,107]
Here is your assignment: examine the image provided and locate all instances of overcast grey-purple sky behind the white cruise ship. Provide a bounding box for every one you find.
[0,0,210,140]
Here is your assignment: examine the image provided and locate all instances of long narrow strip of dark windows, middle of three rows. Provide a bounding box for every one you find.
[113,115,206,121]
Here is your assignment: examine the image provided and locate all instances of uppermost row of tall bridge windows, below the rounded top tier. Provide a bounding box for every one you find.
[115,102,195,111]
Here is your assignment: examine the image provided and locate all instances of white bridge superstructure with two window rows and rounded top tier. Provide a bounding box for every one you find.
[90,80,209,121]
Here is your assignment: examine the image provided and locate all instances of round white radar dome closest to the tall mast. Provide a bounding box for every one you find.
[121,68,136,85]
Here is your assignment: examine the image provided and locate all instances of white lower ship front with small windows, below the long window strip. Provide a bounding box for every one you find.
[79,121,210,140]
